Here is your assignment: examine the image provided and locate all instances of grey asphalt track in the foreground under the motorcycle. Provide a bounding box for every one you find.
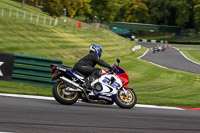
[0,96,200,133]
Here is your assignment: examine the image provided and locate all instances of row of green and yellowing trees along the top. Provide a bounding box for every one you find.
[14,0,200,31]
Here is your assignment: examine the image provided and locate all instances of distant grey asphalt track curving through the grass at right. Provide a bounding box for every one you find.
[138,43,200,74]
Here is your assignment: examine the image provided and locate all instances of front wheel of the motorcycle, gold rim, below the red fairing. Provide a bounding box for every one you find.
[115,88,137,109]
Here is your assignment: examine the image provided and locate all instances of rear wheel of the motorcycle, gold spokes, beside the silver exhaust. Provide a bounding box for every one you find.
[52,81,79,105]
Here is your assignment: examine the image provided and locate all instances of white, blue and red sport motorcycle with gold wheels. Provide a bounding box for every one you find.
[51,58,137,109]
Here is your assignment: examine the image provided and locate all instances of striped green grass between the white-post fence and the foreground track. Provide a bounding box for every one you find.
[0,0,200,107]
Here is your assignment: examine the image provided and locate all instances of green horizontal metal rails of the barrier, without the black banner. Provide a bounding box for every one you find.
[12,54,62,87]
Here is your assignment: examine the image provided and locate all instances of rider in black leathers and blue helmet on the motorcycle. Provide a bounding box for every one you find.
[74,44,113,89]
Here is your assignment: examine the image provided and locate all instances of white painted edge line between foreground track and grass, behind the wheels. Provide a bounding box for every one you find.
[0,93,185,110]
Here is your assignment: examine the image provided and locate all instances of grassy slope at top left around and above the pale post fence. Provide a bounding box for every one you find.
[0,0,95,31]
